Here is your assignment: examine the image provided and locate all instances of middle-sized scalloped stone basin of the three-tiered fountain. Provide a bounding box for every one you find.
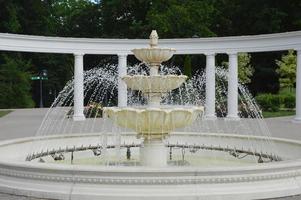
[122,75,187,93]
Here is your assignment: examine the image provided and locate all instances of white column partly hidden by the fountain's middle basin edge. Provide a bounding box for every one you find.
[118,54,127,107]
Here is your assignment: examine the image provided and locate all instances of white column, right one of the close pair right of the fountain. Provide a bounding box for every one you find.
[227,53,239,119]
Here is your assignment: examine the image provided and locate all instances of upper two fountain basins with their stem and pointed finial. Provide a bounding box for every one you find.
[122,30,187,101]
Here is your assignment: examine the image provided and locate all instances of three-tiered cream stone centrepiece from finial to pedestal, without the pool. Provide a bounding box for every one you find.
[105,30,204,167]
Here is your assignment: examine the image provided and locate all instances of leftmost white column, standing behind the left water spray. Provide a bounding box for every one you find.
[73,53,85,121]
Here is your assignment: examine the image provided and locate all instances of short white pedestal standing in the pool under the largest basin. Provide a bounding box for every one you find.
[140,139,167,167]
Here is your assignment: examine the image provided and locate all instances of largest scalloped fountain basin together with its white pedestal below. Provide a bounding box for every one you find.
[105,106,203,167]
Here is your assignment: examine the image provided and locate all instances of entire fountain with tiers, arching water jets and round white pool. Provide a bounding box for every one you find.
[0,31,301,200]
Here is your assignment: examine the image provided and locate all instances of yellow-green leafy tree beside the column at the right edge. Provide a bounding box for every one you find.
[276,50,297,89]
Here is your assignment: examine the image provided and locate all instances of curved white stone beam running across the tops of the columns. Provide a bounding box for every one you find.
[0,31,301,55]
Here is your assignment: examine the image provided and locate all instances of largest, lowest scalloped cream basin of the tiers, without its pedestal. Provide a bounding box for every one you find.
[104,106,204,138]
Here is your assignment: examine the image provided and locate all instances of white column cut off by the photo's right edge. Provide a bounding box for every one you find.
[294,50,301,122]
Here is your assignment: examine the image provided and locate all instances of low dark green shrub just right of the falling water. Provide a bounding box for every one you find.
[256,94,282,112]
